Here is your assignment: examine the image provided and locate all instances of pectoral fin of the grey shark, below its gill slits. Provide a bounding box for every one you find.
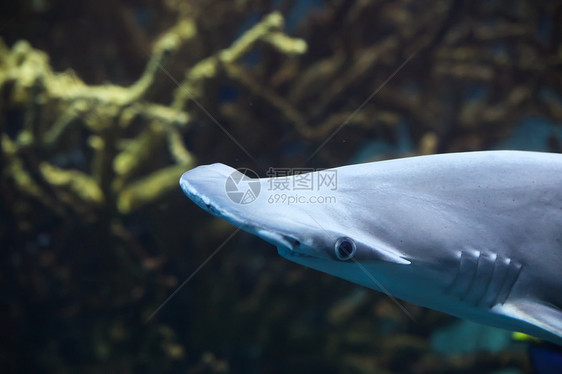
[493,299,562,345]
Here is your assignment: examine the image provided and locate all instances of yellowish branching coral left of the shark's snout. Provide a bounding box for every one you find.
[0,12,306,214]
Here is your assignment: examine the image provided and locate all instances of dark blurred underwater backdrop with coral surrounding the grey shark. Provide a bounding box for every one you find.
[0,0,562,374]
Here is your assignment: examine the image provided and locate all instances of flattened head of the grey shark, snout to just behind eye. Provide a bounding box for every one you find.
[180,164,410,289]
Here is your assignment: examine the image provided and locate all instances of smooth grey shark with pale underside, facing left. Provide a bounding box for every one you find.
[180,151,562,345]
